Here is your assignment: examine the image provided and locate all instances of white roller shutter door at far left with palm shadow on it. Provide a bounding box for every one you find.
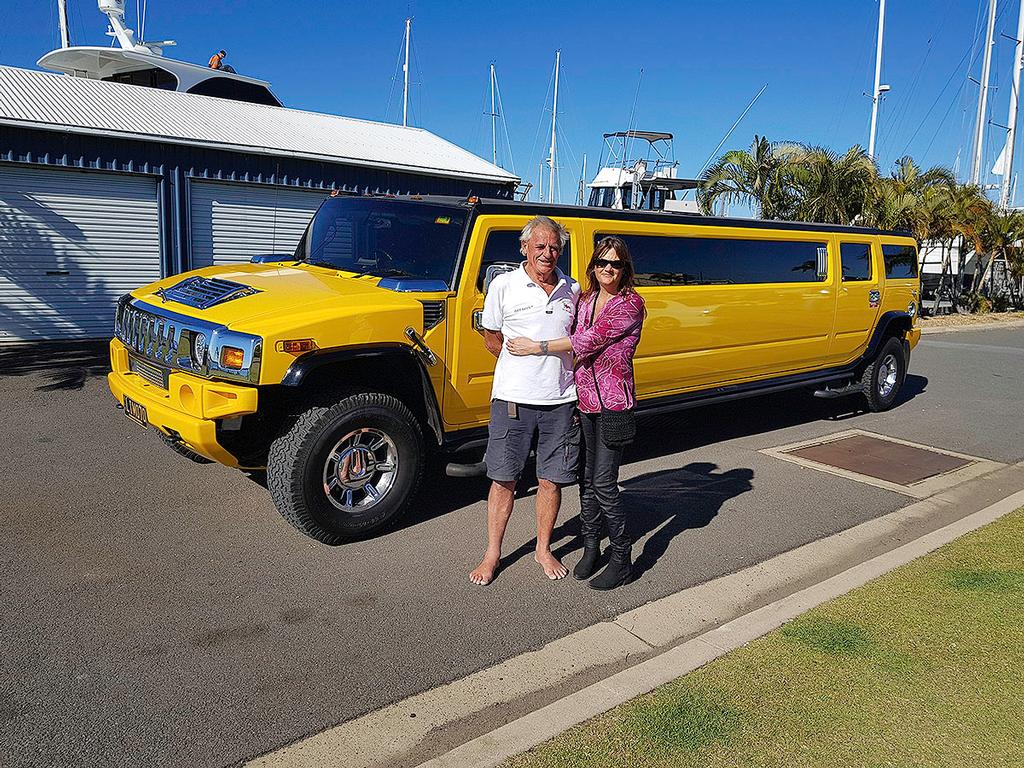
[0,165,161,344]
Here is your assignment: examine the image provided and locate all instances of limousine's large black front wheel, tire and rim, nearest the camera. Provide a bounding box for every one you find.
[266,392,425,544]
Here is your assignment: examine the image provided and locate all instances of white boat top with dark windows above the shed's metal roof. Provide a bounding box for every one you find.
[38,0,282,106]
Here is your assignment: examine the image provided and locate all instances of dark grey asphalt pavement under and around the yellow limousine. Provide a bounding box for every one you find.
[0,329,1024,766]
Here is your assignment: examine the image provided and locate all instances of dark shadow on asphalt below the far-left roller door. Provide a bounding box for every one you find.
[0,340,111,392]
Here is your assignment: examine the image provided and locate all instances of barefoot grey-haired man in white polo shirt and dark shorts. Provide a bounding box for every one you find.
[469,216,580,586]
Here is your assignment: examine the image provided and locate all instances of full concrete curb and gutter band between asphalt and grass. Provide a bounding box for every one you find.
[247,462,1024,768]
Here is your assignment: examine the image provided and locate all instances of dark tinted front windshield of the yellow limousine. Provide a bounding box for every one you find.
[296,198,469,288]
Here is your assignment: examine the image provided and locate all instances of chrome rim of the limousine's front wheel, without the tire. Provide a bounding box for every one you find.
[324,428,398,514]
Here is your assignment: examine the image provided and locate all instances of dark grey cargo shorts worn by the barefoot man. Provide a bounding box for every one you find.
[484,400,580,485]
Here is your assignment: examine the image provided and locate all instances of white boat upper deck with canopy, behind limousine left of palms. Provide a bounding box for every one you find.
[588,130,700,213]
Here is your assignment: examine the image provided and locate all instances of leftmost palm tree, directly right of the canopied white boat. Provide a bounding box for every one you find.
[697,136,794,219]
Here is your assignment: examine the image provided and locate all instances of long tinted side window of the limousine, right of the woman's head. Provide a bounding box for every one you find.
[596,232,826,286]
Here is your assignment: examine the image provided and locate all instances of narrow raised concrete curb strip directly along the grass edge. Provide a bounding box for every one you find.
[420,490,1024,768]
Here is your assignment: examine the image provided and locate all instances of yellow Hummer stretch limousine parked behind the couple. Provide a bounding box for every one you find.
[109,197,921,544]
